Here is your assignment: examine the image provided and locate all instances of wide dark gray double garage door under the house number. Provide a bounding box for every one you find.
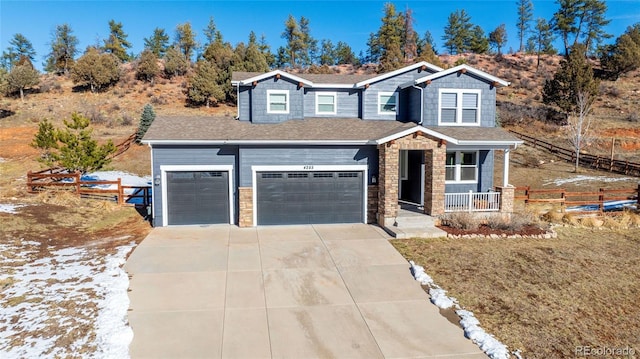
[255,170,366,225]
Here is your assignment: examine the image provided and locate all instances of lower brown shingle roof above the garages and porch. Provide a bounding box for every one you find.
[143,116,519,143]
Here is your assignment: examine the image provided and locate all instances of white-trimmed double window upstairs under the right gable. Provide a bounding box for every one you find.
[438,89,481,126]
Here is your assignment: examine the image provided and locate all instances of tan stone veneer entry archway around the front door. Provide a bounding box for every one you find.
[378,132,446,226]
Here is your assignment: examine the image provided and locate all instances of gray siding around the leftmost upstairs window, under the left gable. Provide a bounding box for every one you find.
[250,77,304,123]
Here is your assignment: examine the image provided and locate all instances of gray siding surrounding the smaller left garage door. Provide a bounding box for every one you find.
[152,146,238,226]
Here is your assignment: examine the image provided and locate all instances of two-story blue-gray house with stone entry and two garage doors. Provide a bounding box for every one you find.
[143,62,521,226]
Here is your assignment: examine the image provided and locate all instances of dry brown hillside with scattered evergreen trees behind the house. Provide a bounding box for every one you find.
[0,0,640,164]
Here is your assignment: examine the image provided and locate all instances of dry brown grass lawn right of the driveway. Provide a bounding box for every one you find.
[392,227,640,359]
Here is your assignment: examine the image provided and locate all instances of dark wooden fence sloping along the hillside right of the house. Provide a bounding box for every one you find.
[509,130,640,177]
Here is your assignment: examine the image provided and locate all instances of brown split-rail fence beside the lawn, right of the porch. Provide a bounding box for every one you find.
[514,184,640,213]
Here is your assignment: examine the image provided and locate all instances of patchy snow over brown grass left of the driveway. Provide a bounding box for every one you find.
[0,241,134,358]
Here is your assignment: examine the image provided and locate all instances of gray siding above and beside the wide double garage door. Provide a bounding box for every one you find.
[239,146,378,187]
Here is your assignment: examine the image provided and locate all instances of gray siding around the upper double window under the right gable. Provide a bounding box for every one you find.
[424,72,496,127]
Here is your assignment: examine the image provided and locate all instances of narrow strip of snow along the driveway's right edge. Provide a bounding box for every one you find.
[409,261,509,359]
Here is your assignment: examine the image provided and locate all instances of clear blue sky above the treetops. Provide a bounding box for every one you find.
[0,0,640,67]
